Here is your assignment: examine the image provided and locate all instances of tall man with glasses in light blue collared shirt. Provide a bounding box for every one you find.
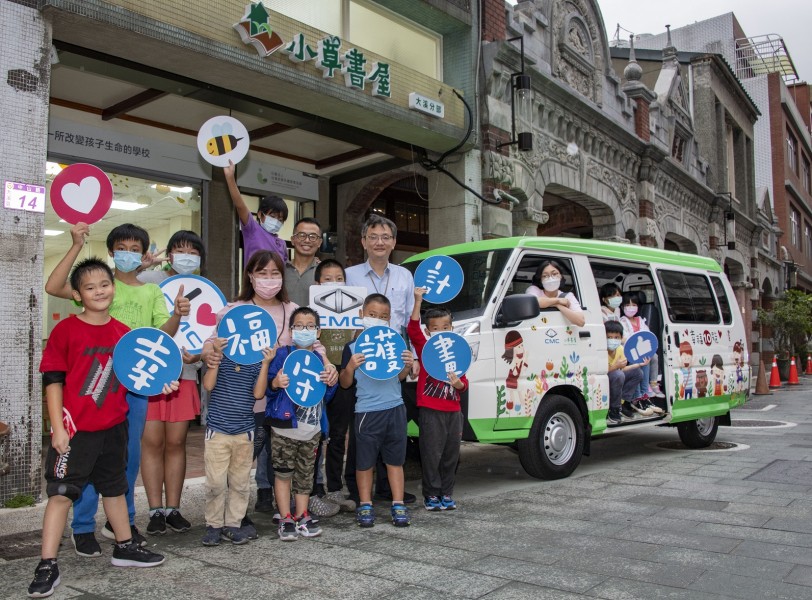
[344,214,417,503]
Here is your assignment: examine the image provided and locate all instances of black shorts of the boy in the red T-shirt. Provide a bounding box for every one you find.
[45,420,128,501]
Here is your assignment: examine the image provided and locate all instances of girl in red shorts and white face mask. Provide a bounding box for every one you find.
[138,230,206,535]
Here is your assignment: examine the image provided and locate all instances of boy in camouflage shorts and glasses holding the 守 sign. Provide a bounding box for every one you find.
[254,306,338,542]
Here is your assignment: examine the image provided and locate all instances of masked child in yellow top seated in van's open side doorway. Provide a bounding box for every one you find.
[603,321,644,426]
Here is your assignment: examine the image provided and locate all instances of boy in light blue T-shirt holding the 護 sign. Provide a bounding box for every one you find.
[339,294,414,527]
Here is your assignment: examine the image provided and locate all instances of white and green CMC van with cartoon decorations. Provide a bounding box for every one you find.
[404,237,750,479]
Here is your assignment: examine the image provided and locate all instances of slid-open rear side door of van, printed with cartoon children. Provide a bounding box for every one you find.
[657,268,735,422]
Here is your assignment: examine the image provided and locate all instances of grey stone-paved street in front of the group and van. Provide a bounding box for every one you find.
[0,379,812,600]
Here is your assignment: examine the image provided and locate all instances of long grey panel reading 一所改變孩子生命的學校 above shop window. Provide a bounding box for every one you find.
[48,115,211,180]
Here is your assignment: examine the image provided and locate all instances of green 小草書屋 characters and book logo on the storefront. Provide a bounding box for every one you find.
[233,2,392,98]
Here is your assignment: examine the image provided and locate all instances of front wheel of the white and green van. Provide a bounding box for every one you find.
[518,396,584,479]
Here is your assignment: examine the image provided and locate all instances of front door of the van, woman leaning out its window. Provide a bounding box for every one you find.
[492,250,608,430]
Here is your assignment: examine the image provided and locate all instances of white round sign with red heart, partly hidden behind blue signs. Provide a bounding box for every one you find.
[158,275,226,354]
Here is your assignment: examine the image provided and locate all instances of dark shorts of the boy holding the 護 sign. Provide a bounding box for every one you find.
[355,404,406,471]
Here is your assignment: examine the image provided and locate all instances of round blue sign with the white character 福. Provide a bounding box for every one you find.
[217,304,276,365]
